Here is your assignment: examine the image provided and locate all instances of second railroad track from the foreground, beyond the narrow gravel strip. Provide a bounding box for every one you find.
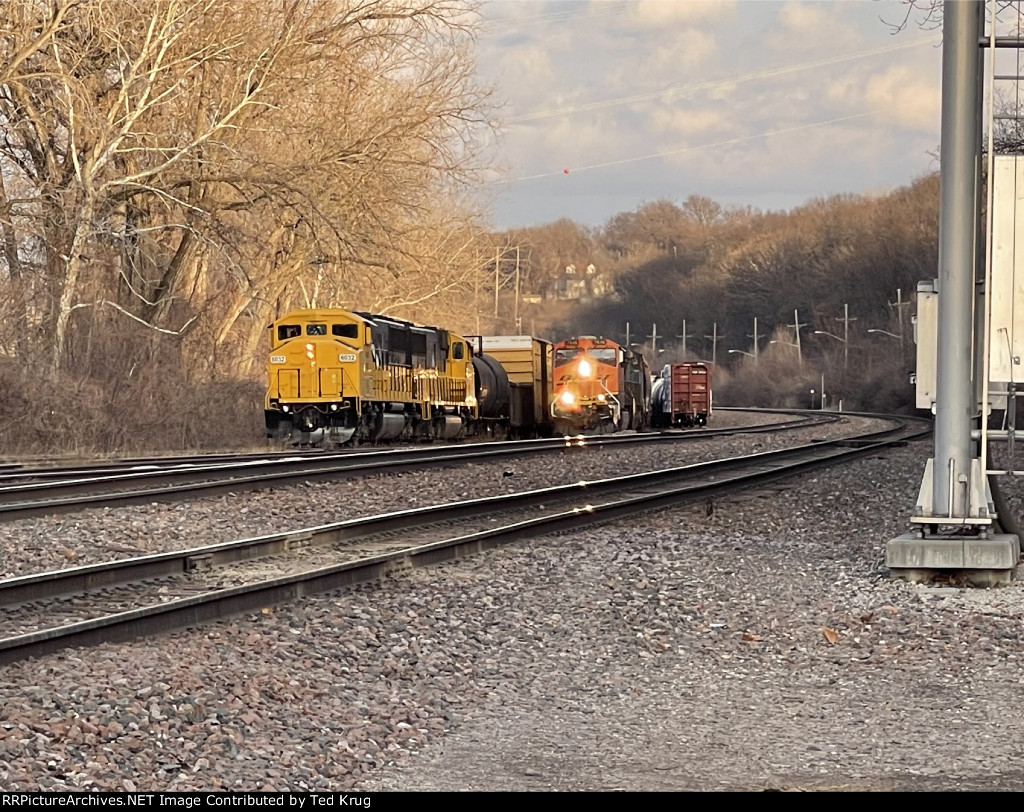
[0,413,844,520]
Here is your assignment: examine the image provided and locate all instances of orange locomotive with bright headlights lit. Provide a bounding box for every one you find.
[551,336,651,434]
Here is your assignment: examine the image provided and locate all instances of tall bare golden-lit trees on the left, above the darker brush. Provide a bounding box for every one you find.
[0,0,495,369]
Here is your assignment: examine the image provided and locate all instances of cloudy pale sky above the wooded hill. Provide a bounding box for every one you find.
[478,0,941,229]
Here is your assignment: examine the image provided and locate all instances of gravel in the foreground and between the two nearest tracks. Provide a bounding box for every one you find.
[0,416,1024,790]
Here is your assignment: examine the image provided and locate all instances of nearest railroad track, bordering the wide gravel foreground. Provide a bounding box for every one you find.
[0,415,931,664]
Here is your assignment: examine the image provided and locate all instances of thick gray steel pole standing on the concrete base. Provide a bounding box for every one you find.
[932,0,984,518]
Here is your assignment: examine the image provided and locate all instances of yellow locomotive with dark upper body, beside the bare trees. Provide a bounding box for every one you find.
[264,308,479,443]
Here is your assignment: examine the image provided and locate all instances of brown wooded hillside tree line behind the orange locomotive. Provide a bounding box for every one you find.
[495,180,939,411]
